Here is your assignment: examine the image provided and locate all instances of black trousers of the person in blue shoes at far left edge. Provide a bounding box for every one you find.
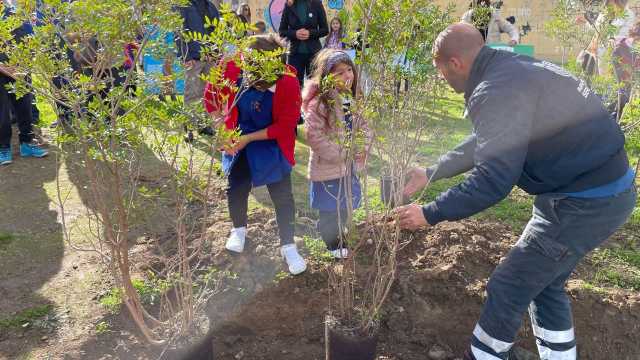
[0,74,33,148]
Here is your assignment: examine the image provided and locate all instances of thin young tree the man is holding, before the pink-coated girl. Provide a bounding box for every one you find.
[318,0,450,344]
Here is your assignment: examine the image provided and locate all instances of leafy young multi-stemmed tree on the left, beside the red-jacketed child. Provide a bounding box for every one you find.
[0,0,282,345]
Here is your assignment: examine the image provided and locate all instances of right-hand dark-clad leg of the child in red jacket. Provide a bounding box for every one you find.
[267,174,296,245]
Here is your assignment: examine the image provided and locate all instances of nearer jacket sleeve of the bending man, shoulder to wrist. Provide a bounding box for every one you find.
[423,84,537,225]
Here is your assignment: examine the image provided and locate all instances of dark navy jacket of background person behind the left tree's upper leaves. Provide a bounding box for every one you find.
[176,0,220,61]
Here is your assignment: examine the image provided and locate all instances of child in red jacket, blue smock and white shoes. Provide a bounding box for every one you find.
[204,34,307,275]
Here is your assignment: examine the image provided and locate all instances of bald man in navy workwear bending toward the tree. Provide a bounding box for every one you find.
[396,23,636,360]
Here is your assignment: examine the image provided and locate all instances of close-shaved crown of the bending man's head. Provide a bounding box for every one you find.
[433,22,484,62]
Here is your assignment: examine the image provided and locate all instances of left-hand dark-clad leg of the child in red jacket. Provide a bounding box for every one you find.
[227,152,251,228]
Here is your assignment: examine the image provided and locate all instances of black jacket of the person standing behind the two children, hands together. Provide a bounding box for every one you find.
[278,0,329,54]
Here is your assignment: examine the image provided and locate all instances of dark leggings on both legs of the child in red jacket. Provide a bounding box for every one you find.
[227,151,296,245]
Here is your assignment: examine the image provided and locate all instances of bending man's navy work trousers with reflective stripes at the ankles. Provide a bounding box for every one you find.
[471,186,637,360]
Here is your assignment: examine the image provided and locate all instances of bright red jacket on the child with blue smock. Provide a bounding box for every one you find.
[204,61,302,166]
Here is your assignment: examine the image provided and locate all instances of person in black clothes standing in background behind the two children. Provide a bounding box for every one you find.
[278,0,329,86]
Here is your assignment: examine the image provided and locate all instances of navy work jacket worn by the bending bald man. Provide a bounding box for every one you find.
[423,47,629,225]
